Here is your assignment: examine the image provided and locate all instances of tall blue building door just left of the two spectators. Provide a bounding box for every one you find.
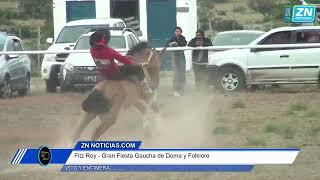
[147,0,177,70]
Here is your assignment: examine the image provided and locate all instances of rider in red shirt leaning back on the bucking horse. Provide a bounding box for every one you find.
[90,29,144,85]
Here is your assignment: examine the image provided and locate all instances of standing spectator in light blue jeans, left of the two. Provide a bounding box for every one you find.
[167,27,187,96]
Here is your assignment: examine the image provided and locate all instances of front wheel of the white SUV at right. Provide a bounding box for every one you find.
[216,67,245,92]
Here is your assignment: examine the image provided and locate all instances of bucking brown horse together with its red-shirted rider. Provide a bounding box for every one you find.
[73,30,166,141]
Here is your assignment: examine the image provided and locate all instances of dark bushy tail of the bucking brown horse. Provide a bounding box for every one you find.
[81,89,112,113]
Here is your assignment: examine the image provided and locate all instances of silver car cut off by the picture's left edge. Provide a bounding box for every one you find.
[0,32,30,98]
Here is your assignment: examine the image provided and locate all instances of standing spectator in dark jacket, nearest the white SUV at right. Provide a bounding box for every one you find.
[188,30,212,90]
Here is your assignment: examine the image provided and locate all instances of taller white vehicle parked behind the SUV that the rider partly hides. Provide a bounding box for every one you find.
[41,18,126,92]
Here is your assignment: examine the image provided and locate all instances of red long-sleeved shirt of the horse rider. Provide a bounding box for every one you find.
[90,47,133,76]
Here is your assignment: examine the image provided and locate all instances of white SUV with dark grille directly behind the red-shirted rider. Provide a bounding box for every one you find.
[59,30,139,91]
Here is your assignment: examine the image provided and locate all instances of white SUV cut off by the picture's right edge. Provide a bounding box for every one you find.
[208,26,320,91]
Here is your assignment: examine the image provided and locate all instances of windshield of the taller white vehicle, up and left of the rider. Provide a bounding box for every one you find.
[56,25,109,43]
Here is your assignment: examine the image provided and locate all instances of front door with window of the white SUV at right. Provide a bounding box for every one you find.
[248,31,292,83]
